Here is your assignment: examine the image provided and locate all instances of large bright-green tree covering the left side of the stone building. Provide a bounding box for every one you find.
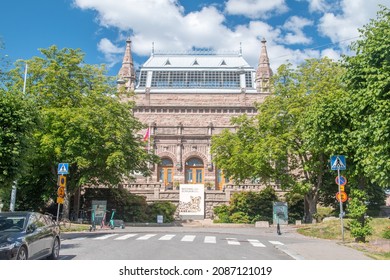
[7,46,155,212]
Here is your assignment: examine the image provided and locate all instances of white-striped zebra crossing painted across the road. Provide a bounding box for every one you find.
[67,233,284,248]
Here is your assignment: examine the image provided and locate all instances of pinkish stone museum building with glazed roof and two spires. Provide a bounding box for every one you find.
[118,39,272,190]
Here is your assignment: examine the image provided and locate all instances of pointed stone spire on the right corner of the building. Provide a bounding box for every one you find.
[256,38,272,92]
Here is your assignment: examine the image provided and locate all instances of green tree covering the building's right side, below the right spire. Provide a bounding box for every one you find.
[212,58,348,222]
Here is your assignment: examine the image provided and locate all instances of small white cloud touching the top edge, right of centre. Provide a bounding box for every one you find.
[226,0,288,19]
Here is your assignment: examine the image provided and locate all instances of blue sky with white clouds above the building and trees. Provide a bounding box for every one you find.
[0,0,390,75]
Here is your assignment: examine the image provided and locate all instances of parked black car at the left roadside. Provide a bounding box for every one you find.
[0,212,60,260]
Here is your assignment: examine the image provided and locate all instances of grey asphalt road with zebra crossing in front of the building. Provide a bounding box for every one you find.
[61,227,370,260]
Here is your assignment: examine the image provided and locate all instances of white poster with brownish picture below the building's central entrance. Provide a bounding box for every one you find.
[179,184,204,220]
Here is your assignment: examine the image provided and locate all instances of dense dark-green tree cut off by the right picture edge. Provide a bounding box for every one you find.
[343,6,390,187]
